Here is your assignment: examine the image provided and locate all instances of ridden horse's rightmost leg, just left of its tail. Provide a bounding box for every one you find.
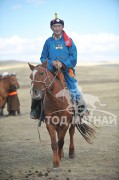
[69,124,75,158]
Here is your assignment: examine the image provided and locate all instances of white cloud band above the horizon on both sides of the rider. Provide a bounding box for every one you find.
[0,33,119,63]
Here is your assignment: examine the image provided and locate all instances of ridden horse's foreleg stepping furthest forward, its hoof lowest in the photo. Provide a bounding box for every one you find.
[46,124,60,168]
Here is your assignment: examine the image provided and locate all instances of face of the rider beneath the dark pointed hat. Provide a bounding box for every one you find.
[51,23,64,36]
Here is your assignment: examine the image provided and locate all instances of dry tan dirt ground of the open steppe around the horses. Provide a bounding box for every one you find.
[0,63,119,180]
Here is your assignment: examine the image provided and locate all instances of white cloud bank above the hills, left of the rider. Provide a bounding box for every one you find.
[0,35,45,61]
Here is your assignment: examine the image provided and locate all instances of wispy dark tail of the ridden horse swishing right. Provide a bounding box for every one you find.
[76,123,95,144]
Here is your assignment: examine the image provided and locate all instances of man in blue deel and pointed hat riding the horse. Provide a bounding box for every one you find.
[30,14,89,120]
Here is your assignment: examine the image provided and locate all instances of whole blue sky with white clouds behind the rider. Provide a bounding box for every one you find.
[0,0,119,64]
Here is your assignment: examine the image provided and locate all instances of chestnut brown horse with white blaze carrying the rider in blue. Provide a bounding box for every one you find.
[29,62,94,169]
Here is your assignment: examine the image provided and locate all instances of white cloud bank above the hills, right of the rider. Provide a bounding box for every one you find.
[70,33,119,61]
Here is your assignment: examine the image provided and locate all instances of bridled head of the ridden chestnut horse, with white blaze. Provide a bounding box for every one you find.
[29,62,53,100]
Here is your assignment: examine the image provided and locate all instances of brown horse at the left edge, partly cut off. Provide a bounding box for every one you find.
[0,74,19,116]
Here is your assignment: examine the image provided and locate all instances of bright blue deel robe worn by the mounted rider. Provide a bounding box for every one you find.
[40,36,80,100]
